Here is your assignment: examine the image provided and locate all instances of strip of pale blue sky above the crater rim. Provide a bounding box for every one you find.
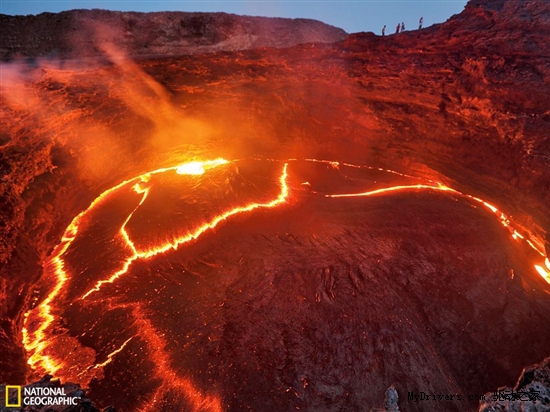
[0,0,470,34]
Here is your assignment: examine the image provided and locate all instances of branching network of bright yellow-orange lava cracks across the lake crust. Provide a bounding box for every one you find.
[22,158,550,412]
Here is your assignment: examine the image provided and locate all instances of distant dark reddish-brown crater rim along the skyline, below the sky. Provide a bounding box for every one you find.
[0,10,346,60]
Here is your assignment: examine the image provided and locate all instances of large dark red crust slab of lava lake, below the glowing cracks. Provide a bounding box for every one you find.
[76,192,550,411]
